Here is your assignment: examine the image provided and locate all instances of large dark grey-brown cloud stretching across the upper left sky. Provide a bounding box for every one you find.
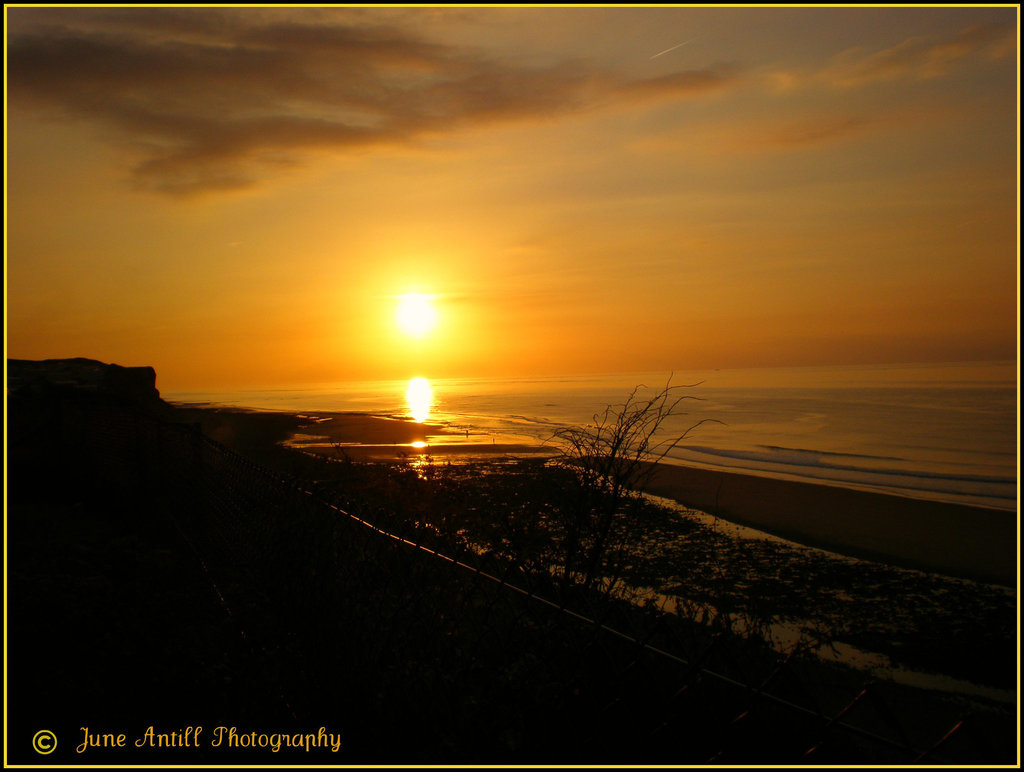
[7,8,735,194]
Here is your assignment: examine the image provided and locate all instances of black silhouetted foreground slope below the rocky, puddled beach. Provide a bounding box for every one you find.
[6,360,1013,765]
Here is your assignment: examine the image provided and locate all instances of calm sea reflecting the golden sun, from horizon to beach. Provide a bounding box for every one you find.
[164,361,1019,512]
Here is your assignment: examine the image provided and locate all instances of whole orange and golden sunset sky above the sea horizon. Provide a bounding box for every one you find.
[5,7,1018,389]
